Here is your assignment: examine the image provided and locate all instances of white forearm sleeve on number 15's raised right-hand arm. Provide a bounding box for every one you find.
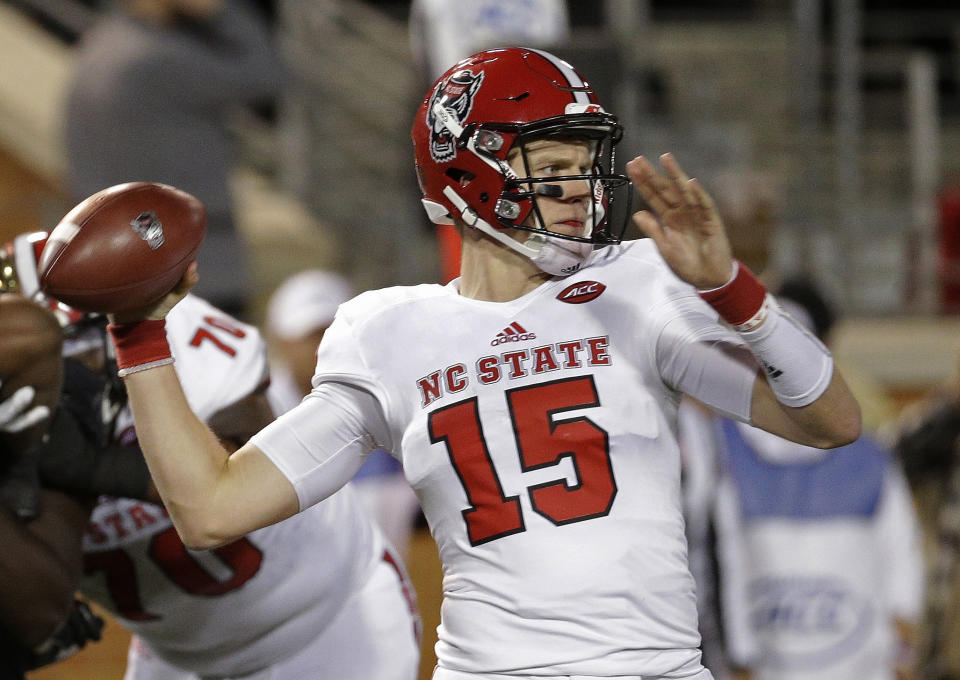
[737,295,833,407]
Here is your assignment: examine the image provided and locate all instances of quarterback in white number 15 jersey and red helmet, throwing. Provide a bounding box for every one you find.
[101,48,860,680]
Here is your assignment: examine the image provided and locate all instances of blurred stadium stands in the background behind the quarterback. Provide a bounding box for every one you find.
[0,0,960,678]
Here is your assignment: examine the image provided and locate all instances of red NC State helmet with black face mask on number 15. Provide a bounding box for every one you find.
[412,47,632,251]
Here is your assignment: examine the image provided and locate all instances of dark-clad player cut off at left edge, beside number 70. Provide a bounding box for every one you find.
[0,286,102,680]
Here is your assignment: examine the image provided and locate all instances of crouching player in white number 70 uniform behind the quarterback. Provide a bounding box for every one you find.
[4,234,419,680]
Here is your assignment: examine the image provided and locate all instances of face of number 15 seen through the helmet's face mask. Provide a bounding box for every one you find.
[508,139,593,236]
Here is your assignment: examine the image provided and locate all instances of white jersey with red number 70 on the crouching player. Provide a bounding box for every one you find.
[81,296,385,676]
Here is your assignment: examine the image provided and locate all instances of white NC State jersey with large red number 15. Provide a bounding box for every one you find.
[278,241,754,676]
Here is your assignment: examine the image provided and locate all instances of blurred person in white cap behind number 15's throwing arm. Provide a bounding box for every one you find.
[266,269,420,558]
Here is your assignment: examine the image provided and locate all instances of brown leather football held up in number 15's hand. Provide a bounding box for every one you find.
[38,182,207,314]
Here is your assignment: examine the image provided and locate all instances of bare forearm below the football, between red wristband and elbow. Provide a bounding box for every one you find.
[124,365,236,546]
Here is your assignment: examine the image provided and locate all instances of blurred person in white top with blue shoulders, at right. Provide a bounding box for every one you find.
[681,279,924,680]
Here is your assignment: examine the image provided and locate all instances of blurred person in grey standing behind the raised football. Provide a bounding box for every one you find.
[65,0,283,315]
